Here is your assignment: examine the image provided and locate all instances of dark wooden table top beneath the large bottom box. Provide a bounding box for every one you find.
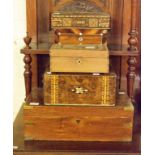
[13,102,141,155]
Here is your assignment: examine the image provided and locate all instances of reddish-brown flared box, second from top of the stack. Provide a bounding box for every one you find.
[55,28,107,45]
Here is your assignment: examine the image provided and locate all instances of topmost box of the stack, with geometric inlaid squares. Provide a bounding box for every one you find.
[51,12,110,29]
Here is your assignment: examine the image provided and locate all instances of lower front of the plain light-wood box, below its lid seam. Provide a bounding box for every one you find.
[50,57,109,73]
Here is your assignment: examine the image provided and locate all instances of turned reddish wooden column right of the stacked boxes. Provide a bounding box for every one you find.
[127,0,138,100]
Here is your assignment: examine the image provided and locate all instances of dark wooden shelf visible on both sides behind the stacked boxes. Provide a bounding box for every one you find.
[21,43,140,56]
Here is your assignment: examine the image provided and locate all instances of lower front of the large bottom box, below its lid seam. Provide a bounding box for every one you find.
[25,116,132,141]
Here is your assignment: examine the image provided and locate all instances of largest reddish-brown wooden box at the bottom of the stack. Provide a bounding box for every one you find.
[24,94,134,142]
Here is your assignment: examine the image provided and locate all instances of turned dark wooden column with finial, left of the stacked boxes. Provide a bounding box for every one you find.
[23,33,32,101]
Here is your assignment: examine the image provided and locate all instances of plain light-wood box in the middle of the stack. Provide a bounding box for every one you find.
[50,44,109,73]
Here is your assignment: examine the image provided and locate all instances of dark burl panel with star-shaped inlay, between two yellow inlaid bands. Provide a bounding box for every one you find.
[59,76,102,104]
